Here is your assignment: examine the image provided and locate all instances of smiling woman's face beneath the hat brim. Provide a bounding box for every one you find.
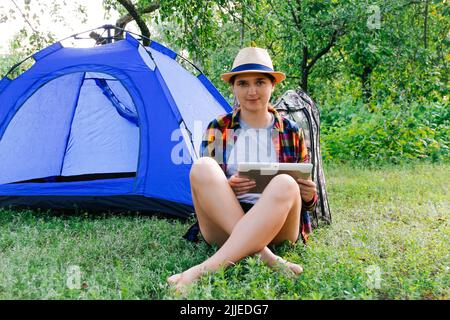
[233,72,275,111]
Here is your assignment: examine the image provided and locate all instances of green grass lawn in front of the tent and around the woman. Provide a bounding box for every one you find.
[0,165,450,299]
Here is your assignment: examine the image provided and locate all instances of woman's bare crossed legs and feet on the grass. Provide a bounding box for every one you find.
[168,158,302,283]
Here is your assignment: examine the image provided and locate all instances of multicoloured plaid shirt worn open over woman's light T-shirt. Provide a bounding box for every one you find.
[200,107,318,242]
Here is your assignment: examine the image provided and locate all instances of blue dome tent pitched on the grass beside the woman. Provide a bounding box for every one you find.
[0,33,231,217]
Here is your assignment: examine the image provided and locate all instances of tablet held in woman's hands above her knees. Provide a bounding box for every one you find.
[238,162,313,193]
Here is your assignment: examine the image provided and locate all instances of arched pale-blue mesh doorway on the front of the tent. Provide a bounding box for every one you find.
[0,72,140,184]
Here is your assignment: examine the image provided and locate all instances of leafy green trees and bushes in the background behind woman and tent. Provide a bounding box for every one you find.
[0,0,450,168]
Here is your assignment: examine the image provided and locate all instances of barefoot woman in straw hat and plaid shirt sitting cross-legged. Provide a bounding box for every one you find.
[167,47,317,290]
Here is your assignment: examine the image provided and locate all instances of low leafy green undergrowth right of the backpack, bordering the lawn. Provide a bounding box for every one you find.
[321,101,450,166]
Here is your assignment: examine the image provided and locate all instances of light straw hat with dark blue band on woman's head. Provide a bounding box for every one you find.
[221,47,286,83]
